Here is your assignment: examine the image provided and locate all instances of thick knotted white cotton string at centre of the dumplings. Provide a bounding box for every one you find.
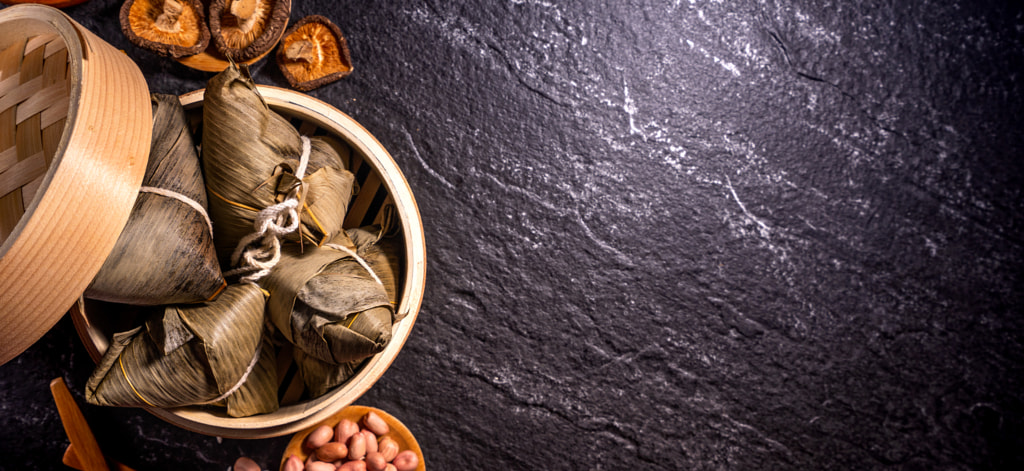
[224,136,310,283]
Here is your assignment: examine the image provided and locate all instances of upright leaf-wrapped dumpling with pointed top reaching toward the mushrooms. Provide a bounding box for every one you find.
[203,63,354,266]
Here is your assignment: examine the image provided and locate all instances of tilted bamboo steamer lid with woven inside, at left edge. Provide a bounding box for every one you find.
[0,4,153,365]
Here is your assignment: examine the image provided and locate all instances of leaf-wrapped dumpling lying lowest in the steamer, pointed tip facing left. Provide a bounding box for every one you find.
[85,284,279,417]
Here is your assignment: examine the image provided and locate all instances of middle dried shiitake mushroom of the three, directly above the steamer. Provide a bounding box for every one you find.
[210,0,292,60]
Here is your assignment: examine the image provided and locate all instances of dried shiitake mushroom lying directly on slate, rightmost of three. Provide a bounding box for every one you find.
[278,14,352,91]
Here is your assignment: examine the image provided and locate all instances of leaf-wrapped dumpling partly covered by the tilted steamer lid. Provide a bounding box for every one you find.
[85,94,226,305]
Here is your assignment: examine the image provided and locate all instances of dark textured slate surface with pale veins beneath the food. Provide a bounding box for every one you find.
[0,0,1024,470]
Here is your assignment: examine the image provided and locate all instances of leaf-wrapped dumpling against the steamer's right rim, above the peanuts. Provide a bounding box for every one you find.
[260,232,394,365]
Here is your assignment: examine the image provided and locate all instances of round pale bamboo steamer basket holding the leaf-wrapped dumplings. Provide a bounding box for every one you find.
[72,86,426,438]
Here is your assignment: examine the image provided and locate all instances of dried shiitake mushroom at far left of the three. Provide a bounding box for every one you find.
[121,0,210,58]
